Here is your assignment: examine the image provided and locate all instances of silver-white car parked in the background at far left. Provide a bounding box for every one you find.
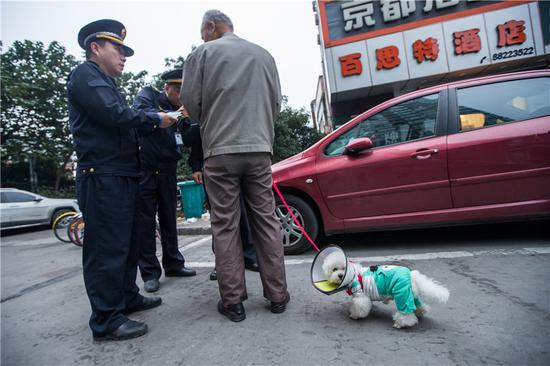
[0,188,79,229]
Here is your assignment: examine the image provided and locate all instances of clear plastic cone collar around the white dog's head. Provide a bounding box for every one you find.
[311,245,355,295]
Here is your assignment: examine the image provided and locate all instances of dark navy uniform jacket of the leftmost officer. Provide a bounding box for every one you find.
[67,61,159,177]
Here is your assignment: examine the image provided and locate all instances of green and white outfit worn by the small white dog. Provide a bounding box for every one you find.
[347,266,422,314]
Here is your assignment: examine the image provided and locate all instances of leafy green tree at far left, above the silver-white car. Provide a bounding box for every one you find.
[1,40,78,189]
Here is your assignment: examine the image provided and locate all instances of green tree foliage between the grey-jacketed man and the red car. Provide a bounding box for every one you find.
[273,97,323,163]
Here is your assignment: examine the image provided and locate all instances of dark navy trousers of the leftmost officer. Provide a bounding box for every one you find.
[76,174,147,336]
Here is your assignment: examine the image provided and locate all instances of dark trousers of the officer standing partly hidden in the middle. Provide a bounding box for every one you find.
[139,171,185,281]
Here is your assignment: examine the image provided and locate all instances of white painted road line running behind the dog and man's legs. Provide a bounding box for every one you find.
[188,244,550,268]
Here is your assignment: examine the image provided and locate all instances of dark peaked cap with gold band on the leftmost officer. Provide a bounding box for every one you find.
[78,19,134,57]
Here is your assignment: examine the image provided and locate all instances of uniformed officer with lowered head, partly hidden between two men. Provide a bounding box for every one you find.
[133,68,196,292]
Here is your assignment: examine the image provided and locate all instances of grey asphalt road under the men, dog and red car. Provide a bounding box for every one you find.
[1,221,550,365]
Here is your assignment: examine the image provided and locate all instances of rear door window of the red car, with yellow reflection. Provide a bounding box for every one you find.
[457,78,550,131]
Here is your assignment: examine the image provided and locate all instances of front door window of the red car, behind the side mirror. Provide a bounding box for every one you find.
[325,93,439,156]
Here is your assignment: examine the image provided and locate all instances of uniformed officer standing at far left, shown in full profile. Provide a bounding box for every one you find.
[67,19,176,341]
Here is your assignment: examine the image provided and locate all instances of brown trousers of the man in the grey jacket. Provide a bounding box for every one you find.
[204,153,287,306]
